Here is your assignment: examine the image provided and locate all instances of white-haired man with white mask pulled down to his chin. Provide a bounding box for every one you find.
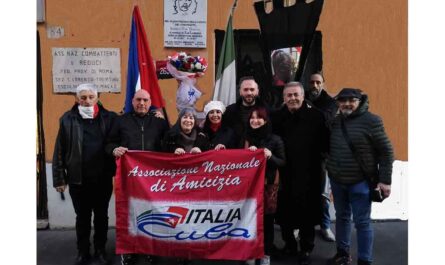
[53,84,116,265]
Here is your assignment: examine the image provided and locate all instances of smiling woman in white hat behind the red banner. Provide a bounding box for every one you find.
[202,101,238,150]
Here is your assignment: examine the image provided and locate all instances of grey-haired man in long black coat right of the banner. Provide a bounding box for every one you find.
[272,82,328,264]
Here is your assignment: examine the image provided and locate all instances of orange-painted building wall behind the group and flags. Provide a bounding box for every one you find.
[37,0,408,161]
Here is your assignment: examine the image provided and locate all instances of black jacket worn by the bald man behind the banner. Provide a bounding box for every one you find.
[105,112,169,155]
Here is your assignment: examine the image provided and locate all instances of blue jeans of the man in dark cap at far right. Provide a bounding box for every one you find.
[331,180,374,262]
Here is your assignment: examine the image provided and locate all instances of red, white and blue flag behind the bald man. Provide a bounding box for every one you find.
[124,6,165,113]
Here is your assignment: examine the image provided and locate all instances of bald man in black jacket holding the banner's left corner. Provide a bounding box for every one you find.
[105,89,169,265]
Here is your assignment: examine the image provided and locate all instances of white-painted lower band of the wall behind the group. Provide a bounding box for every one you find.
[46,161,408,229]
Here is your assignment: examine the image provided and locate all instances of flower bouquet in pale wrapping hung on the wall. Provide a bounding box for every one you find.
[167,52,207,111]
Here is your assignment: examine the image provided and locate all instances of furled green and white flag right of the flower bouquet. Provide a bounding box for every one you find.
[213,1,237,106]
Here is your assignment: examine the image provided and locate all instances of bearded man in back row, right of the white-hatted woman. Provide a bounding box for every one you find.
[222,76,265,148]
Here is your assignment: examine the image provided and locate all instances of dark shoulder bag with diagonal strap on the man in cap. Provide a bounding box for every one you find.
[341,117,386,202]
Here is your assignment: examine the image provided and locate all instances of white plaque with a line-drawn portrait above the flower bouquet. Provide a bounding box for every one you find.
[164,0,207,48]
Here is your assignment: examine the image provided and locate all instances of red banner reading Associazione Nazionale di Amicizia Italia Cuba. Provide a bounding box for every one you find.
[115,149,265,260]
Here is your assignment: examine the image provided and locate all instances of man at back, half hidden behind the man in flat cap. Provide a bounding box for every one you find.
[308,72,337,242]
